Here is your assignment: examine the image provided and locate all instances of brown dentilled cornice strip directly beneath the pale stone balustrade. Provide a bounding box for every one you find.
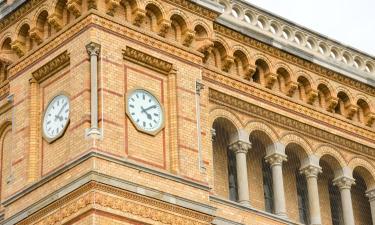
[214,23,375,96]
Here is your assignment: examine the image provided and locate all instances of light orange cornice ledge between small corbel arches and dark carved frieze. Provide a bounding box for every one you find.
[203,69,375,142]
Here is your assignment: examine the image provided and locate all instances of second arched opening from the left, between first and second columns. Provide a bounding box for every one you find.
[247,130,274,213]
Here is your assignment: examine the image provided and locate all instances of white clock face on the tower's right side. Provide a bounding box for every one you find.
[126,89,164,134]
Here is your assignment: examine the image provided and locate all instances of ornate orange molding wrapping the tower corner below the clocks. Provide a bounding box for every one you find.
[18,181,214,225]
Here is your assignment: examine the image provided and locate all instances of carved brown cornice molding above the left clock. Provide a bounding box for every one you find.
[32,51,70,83]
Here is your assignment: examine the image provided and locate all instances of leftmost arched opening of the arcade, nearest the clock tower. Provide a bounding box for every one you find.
[213,118,238,201]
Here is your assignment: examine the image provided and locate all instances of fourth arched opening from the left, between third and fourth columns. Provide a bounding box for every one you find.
[318,155,344,225]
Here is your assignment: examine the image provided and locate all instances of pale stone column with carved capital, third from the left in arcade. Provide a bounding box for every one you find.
[300,156,322,225]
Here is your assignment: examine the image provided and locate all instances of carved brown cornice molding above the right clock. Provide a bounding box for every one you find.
[122,46,173,74]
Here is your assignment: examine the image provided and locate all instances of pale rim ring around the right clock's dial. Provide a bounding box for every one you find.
[125,87,165,136]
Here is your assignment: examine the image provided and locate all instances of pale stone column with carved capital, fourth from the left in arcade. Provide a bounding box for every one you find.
[333,176,355,225]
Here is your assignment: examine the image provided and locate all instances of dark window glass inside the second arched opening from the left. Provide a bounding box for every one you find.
[262,161,274,213]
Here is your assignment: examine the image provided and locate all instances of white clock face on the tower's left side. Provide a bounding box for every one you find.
[43,94,70,142]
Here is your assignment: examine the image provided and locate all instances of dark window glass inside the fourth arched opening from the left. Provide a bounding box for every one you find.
[328,182,344,225]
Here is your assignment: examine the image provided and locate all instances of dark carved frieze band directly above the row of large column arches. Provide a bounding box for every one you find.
[209,88,375,157]
